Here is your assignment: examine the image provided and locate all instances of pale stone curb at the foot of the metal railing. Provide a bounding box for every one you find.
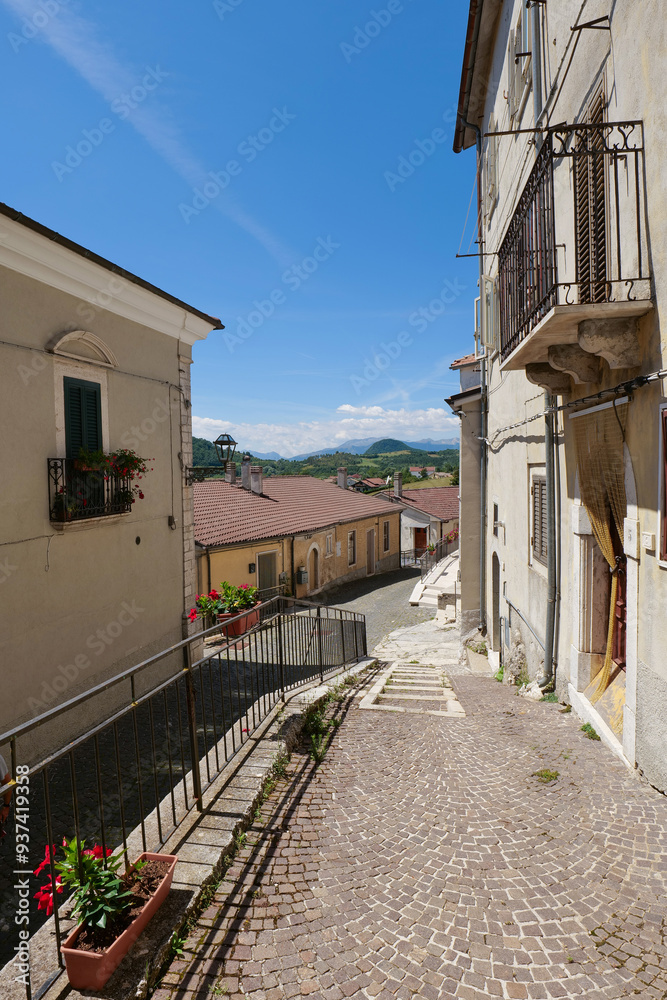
[31,657,377,1000]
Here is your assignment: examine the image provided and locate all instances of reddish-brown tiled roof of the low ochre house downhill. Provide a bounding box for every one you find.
[193,476,403,545]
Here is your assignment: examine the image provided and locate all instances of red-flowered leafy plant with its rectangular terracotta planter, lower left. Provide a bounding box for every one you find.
[35,839,178,990]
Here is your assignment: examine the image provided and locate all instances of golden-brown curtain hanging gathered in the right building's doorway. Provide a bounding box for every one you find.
[572,402,628,701]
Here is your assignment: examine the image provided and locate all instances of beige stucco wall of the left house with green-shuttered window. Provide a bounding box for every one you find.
[0,268,209,752]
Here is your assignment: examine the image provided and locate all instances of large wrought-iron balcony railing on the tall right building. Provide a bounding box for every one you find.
[498,121,651,361]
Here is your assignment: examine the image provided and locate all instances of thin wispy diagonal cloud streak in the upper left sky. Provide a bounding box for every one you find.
[0,0,297,267]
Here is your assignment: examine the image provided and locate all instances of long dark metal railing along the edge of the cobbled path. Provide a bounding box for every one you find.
[0,596,366,1000]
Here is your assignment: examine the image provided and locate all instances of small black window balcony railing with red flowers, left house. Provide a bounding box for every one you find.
[48,458,132,521]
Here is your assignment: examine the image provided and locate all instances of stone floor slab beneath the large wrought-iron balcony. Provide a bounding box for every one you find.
[500,299,653,371]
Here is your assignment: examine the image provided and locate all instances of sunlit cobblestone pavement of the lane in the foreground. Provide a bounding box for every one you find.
[155,616,667,1000]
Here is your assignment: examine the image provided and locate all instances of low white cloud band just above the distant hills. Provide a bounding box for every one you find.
[192,403,459,458]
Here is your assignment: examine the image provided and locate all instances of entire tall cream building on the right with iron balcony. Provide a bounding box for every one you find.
[449,0,667,791]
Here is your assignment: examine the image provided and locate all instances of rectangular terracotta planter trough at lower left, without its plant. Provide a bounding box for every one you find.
[60,851,178,990]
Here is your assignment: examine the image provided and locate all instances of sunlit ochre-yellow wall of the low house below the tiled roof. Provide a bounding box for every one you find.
[197,505,400,598]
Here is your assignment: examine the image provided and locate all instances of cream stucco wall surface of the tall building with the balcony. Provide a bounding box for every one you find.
[461,0,667,790]
